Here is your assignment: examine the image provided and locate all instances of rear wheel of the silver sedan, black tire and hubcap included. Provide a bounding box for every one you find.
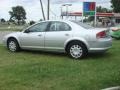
[67,41,88,59]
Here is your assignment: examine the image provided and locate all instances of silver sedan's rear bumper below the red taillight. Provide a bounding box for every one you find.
[88,38,112,52]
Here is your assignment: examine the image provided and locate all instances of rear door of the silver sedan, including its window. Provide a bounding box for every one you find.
[45,21,72,50]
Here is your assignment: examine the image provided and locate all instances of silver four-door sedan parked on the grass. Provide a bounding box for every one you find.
[3,20,112,59]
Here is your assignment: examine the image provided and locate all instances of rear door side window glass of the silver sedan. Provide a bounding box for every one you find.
[49,22,71,31]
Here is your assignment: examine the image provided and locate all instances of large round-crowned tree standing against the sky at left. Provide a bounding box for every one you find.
[9,6,26,25]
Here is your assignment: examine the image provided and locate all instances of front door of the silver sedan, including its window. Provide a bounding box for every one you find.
[19,22,48,49]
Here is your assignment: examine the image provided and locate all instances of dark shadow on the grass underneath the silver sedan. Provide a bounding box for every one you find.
[22,50,111,60]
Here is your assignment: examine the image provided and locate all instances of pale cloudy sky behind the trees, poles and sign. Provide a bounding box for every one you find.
[0,0,111,21]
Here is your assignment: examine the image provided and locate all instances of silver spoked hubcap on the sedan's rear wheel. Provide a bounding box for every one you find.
[70,45,83,59]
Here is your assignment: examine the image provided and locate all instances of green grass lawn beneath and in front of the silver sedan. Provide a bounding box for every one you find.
[0,41,120,90]
